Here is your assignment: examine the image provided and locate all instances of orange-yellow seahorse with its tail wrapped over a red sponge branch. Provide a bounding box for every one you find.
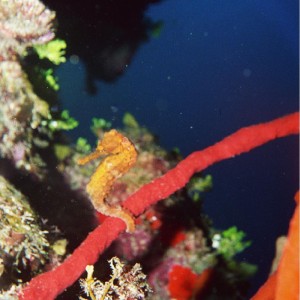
[78,129,137,232]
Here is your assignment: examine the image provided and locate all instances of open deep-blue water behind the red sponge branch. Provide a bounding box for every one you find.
[58,0,299,292]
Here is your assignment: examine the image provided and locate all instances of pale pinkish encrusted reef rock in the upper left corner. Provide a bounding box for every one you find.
[0,0,55,171]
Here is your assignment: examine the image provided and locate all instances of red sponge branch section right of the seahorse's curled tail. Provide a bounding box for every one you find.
[123,112,299,216]
